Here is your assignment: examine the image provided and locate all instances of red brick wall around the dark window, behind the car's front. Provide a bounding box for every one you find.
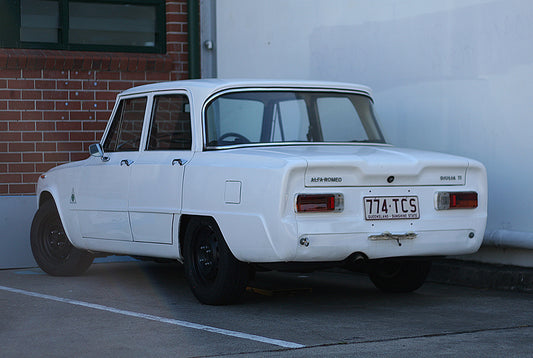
[0,0,188,195]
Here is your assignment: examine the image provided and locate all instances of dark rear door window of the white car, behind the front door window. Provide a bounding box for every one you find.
[146,94,192,150]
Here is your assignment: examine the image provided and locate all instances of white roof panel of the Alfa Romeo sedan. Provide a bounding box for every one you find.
[120,78,371,97]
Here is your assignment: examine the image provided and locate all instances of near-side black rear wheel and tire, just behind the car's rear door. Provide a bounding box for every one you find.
[183,218,249,305]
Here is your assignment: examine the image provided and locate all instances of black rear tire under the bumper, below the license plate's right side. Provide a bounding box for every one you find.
[368,260,431,293]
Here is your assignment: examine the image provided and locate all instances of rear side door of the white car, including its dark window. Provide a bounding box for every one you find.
[129,93,192,244]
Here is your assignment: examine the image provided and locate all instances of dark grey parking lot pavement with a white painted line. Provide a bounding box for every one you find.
[0,261,533,357]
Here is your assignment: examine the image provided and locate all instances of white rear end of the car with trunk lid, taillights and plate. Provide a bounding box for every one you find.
[286,146,487,261]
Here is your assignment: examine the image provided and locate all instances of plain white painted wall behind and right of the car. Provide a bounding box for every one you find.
[216,0,533,252]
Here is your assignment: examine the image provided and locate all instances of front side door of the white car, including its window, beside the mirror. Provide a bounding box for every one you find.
[73,97,147,241]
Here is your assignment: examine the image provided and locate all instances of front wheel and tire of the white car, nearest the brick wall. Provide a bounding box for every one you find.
[30,200,94,276]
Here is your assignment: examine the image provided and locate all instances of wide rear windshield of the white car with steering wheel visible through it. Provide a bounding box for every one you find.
[205,90,385,148]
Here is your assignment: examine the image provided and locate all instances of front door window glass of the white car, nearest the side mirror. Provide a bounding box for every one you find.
[104,97,146,152]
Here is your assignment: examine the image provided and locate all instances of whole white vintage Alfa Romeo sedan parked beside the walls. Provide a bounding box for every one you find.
[31,79,487,304]
